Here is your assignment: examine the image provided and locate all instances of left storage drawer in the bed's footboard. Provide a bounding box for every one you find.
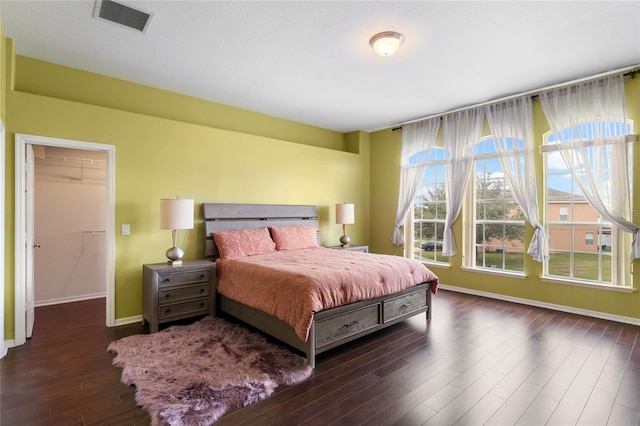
[316,304,380,348]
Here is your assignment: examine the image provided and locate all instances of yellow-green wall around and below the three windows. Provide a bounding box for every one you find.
[369,78,640,319]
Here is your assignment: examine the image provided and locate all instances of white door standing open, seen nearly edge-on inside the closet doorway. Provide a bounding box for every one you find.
[24,144,36,339]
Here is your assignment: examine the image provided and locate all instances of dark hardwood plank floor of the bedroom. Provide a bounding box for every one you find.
[0,290,640,426]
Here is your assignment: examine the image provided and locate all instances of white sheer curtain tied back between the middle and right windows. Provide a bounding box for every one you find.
[485,96,549,262]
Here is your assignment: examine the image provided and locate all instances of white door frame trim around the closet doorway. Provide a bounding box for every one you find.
[14,133,116,346]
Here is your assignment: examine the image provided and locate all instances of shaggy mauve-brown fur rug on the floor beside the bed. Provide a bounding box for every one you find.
[107,317,312,426]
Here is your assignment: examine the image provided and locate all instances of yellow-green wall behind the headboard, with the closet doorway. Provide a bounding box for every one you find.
[5,50,369,339]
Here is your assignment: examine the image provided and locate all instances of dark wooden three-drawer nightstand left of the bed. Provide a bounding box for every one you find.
[142,260,216,333]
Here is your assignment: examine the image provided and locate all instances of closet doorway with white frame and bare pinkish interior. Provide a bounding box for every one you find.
[15,134,115,345]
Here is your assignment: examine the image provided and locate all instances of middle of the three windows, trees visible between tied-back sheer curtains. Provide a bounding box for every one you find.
[466,138,525,272]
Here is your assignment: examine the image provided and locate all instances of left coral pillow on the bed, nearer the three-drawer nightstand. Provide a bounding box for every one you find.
[213,228,276,258]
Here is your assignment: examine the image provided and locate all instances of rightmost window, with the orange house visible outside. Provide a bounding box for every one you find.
[544,123,633,286]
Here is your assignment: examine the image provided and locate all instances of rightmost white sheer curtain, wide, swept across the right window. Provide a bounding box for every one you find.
[540,75,640,259]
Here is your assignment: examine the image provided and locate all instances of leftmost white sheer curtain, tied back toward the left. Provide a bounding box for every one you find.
[391,117,440,246]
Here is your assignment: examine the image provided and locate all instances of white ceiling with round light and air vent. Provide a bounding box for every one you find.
[0,0,640,132]
